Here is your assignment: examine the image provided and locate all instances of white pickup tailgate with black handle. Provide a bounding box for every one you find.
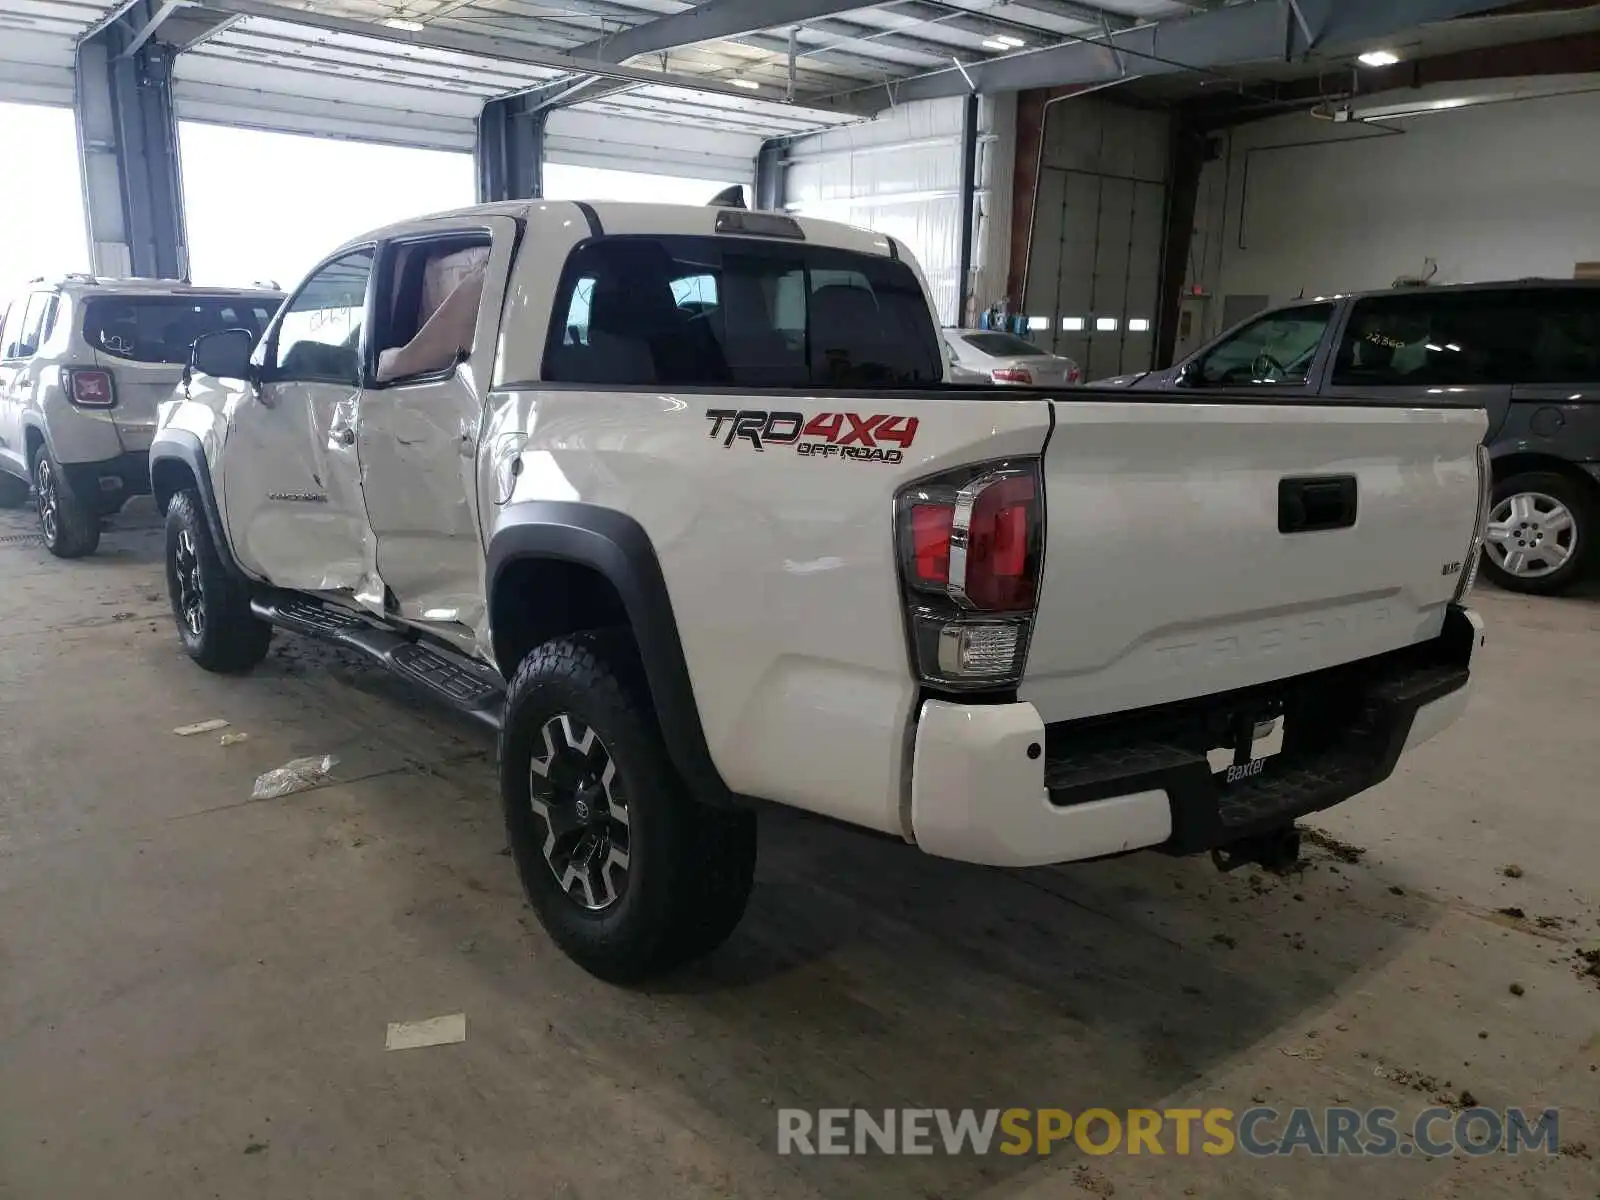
[1021,397,1486,722]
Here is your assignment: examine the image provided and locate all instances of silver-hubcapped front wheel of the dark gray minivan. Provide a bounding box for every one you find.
[1483,470,1592,595]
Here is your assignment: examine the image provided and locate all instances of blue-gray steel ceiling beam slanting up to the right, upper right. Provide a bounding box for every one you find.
[838,0,1516,110]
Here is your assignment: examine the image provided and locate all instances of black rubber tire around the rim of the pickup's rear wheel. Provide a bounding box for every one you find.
[499,630,755,984]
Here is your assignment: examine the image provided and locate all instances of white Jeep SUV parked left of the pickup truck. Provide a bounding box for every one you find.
[0,275,283,558]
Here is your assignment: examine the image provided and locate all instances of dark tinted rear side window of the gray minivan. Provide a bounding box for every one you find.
[1333,288,1600,387]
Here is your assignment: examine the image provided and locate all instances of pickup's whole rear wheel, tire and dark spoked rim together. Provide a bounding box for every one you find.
[499,632,755,982]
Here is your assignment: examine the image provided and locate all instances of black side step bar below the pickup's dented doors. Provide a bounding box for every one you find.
[250,592,506,730]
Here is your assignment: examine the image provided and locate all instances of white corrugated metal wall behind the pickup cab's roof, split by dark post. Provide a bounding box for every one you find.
[784,96,1016,325]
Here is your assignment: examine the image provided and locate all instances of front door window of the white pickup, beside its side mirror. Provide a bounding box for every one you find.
[269,248,373,387]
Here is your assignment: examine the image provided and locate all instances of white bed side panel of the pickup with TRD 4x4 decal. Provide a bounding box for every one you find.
[485,384,1050,834]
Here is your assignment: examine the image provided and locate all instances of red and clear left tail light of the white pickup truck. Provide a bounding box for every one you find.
[896,459,1045,688]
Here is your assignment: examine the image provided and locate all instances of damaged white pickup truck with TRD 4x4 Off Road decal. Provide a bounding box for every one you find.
[150,202,1486,981]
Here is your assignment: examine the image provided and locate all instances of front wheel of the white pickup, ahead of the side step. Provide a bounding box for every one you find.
[166,491,272,675]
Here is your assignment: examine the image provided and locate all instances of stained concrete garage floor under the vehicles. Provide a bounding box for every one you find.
[0,506,1600,1200]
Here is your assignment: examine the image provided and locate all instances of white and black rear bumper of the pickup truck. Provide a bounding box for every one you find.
[910,608,1483,867]
